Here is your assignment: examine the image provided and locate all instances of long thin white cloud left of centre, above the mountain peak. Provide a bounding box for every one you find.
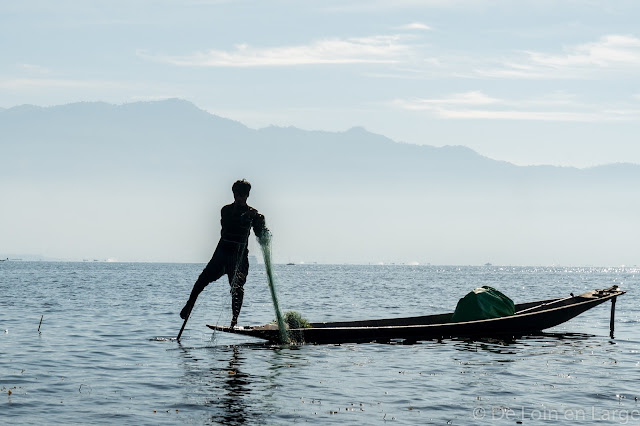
[138,35,413,67]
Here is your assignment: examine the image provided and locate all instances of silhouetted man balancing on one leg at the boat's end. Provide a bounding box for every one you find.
[180,179,269,327]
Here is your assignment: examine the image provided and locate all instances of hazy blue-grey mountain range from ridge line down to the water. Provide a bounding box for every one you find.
[0,99,640,264]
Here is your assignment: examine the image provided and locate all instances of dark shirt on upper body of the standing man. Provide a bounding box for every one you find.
[220,203,266,245]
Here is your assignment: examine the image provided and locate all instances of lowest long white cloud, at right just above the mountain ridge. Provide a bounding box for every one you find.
[391,91,640,122]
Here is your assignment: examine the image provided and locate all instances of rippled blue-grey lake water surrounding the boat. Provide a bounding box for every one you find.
[0,261,640,425]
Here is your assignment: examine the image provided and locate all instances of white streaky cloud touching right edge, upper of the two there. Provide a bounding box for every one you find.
[476,34,640,79]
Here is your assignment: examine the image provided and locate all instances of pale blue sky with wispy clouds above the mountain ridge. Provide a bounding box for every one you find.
[0,0,640,167]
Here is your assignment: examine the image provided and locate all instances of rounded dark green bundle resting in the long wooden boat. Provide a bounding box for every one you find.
[451,285,515,322]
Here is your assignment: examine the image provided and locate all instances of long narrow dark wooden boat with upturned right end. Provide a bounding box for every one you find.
[207,285,626,344]
